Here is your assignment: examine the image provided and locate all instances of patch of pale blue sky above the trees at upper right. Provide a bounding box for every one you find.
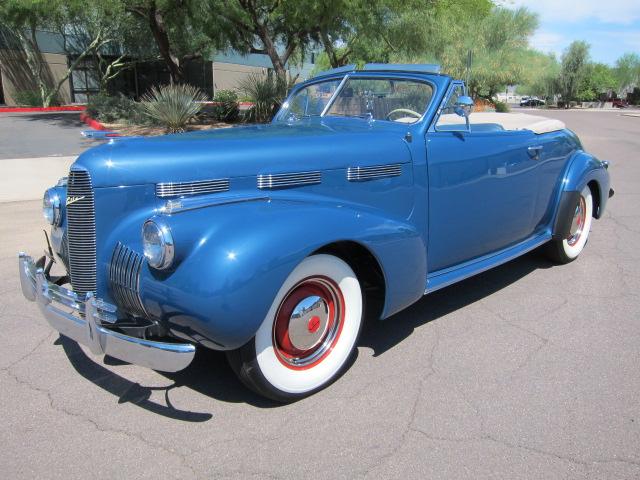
[498,0,640,65]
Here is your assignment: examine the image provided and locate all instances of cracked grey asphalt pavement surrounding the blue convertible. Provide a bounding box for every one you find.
[0,111,640,480]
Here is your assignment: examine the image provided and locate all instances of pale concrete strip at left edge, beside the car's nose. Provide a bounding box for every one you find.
[0,155,78,203]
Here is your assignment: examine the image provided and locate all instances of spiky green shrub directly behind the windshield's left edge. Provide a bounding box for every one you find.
[240,73,289,123]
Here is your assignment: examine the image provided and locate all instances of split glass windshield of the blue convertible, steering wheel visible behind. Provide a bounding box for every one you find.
[278,77,433,123]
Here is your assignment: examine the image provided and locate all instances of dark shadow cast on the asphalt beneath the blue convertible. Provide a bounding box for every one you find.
[56,252,553,414]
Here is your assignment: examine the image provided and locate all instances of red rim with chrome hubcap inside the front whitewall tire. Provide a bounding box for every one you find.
[272,277,344,370]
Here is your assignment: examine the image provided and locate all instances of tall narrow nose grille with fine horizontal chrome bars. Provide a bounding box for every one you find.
[66,170,96,296]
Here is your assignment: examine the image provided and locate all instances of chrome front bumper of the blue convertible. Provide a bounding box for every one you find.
[18,253,196,372]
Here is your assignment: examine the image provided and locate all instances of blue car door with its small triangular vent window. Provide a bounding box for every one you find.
[427,84,538,272]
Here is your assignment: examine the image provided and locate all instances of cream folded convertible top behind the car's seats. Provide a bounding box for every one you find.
[438,112,566,134]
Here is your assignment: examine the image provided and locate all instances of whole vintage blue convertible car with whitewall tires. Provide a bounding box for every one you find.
[19,64,613,402]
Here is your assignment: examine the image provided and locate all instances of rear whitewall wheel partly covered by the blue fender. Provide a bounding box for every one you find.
[547,186,593,263]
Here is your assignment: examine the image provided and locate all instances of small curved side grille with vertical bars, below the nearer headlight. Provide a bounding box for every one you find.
[109,242,146,316]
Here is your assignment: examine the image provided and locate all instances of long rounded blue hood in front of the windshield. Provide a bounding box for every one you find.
[72,119,410,187]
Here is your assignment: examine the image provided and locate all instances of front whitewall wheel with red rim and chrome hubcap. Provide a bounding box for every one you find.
[227,254,363,402]
